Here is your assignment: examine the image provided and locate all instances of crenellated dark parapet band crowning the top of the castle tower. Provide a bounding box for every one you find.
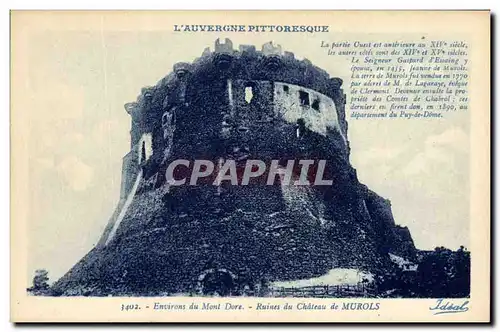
[125,38,347,137]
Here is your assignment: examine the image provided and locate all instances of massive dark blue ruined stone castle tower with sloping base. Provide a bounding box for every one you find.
[54,39,415,295]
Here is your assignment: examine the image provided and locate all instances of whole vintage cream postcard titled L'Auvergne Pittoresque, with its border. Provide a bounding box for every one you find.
[11,11,490,322]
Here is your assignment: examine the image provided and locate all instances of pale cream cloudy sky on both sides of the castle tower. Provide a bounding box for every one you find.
[26,28,469,280]
